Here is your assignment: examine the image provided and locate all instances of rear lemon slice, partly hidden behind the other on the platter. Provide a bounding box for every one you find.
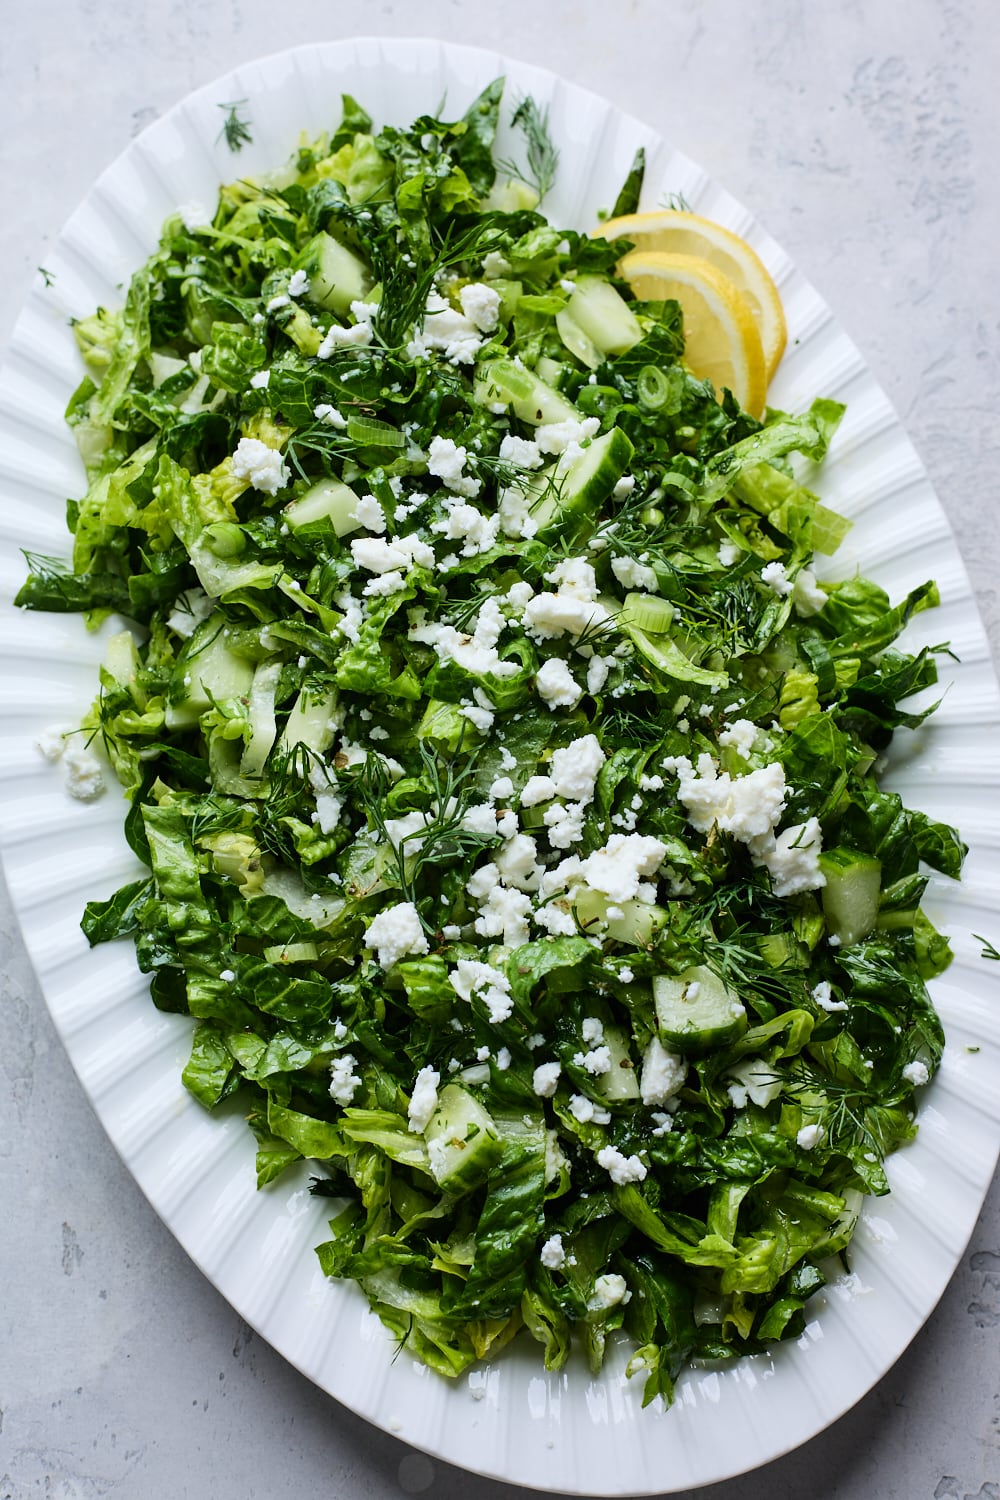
[594,209,787,380]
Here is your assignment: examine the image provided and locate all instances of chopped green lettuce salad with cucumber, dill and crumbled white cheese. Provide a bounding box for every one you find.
[18,80,964,1403]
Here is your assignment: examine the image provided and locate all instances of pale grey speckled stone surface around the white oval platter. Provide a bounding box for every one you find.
[0,0,1000,1500]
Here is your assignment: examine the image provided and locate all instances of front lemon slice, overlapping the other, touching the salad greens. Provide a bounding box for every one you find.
[618,251,768,417]
